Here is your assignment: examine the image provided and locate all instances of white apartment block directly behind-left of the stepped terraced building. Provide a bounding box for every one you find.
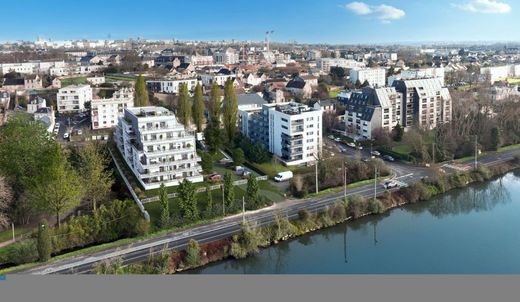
[90,88,134,130]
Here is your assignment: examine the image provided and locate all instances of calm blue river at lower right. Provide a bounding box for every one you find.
[189,171,520,274]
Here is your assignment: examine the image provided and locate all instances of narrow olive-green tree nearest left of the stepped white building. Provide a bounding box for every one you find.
[78,142,114,211]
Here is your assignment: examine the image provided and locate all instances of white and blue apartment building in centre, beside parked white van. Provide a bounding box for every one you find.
[239,102,323,166]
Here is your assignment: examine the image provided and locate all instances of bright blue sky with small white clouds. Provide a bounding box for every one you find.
[0,0,520,44]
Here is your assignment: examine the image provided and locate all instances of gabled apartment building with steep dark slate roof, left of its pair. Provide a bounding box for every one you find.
[345,87,405,140]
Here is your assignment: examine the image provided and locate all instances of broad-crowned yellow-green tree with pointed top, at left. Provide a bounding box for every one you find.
[29,145,83,227]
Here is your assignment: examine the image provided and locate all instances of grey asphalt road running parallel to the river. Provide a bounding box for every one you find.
[15,148,520,275]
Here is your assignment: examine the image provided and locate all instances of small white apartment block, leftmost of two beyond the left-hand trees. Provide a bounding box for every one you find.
[57,85,92,113]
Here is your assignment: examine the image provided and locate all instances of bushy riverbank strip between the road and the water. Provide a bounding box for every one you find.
[97,160,520,274]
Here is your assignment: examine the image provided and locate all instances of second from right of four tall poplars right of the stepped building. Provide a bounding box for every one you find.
[204,82,224,154]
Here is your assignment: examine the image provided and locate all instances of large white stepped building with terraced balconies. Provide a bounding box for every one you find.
[114,106,203,190]
